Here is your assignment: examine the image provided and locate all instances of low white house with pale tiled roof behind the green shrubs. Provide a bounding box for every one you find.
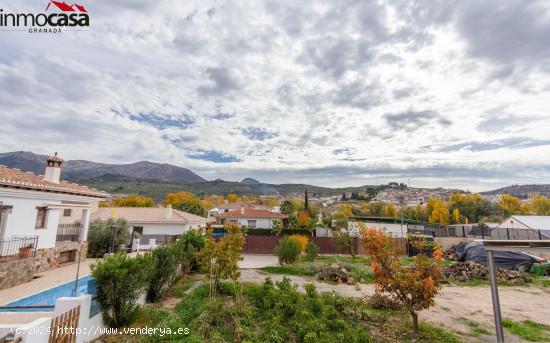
[92,205,213,245]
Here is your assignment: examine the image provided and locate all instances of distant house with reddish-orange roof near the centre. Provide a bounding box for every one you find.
[216,206,287,229]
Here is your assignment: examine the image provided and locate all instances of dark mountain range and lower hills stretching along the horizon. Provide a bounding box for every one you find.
[0,151,550,199]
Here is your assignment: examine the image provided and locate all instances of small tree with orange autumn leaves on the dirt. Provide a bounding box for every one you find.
[363,228,443,333]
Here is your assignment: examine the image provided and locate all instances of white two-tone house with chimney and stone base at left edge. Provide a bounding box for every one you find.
[0,156,108,289]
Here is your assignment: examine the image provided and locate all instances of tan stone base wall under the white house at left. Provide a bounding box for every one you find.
[0,242,88,290]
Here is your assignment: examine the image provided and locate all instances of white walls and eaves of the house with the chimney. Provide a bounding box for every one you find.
[0,188,100,249]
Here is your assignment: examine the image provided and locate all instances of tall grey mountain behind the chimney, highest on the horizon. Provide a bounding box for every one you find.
[0,151,206,184]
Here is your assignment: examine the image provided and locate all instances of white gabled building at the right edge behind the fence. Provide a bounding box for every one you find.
[492,216,550,239]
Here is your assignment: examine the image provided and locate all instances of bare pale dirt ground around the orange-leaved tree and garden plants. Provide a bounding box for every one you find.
[241,269,550,342]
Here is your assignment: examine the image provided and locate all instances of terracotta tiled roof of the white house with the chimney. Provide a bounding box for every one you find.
[0,165,108,198]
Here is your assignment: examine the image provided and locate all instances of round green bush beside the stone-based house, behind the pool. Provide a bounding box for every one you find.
[87,218,131,257]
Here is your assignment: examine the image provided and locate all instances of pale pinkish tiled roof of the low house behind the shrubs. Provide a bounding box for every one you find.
[92,207,215,224]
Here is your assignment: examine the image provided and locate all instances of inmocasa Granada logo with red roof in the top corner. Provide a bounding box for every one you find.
[0,0,90,33]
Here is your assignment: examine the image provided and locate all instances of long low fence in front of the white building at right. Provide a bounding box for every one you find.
[407,225,550,240]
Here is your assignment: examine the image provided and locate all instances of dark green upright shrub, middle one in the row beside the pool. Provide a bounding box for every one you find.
[147,246,177,301]
